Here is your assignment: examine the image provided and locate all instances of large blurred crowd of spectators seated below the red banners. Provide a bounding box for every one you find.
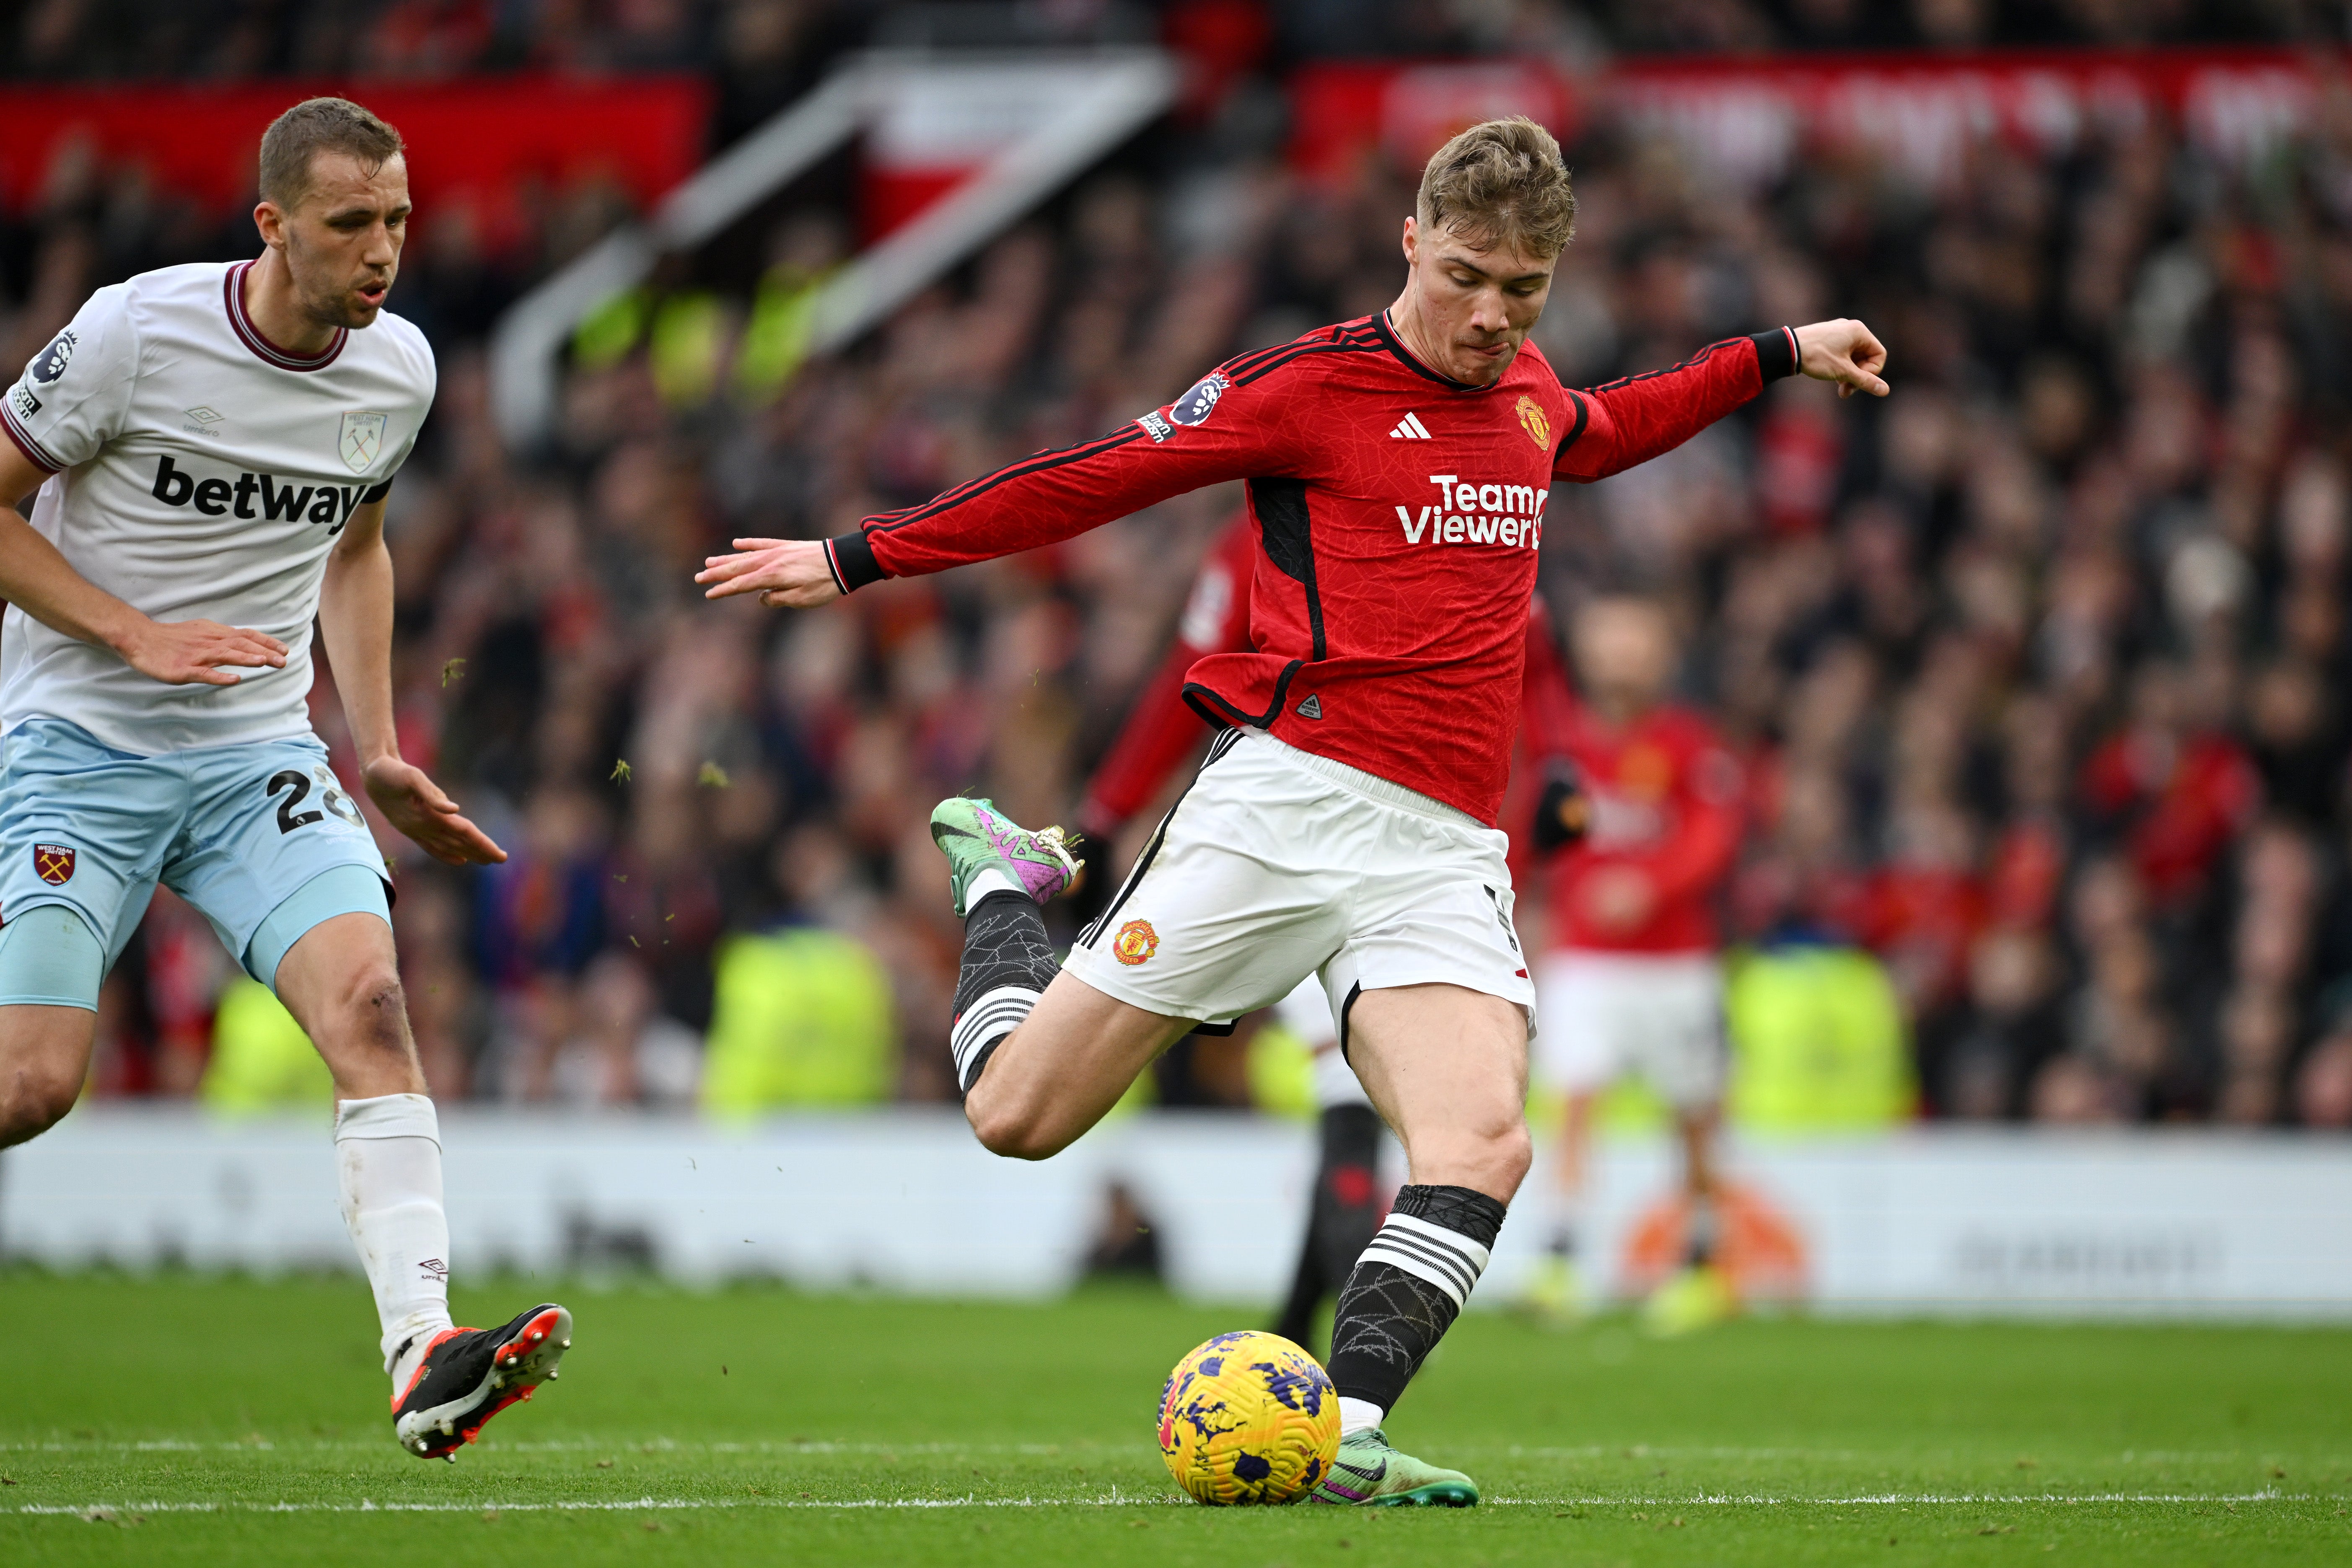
[13,0,2352,1126]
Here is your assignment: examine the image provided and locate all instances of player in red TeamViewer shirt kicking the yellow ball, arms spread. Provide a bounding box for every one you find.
[696,118,1886,1507]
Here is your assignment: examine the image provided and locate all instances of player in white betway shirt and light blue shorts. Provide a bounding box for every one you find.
[0,99,572,1460]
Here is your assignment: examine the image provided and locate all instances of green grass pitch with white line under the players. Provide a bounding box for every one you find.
[0,1272,2352,1568]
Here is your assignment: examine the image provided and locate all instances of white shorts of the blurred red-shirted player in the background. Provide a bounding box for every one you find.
[1531,950,1724,1110]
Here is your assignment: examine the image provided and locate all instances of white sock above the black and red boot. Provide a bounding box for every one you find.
[334,1095,452,1394]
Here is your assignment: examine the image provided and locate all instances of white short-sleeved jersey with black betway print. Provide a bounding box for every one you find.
[0,261,433,757]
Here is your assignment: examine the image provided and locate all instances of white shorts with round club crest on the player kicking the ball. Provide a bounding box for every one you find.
[1063,731,1536,1048]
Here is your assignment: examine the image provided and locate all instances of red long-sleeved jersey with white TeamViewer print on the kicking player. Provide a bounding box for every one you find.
[828,315,1795,823]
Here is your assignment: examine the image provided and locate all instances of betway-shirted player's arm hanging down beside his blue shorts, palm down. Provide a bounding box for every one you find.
[318,501,506,865]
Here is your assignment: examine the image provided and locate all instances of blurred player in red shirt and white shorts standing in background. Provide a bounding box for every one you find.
[1526,597,1741,1333]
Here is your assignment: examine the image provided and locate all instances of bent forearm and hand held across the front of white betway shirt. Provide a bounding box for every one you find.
[0,442,287,686]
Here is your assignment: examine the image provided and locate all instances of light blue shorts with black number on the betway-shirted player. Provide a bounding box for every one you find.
[0,719,391,1009]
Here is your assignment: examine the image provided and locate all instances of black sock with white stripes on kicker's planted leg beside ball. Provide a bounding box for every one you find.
[1331,1187,1503,1410]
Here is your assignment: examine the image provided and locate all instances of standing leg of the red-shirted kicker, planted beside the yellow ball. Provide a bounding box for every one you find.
[1315,985,1531,1507]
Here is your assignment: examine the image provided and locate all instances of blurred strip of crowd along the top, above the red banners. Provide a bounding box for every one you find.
[0,0,2352,87]
